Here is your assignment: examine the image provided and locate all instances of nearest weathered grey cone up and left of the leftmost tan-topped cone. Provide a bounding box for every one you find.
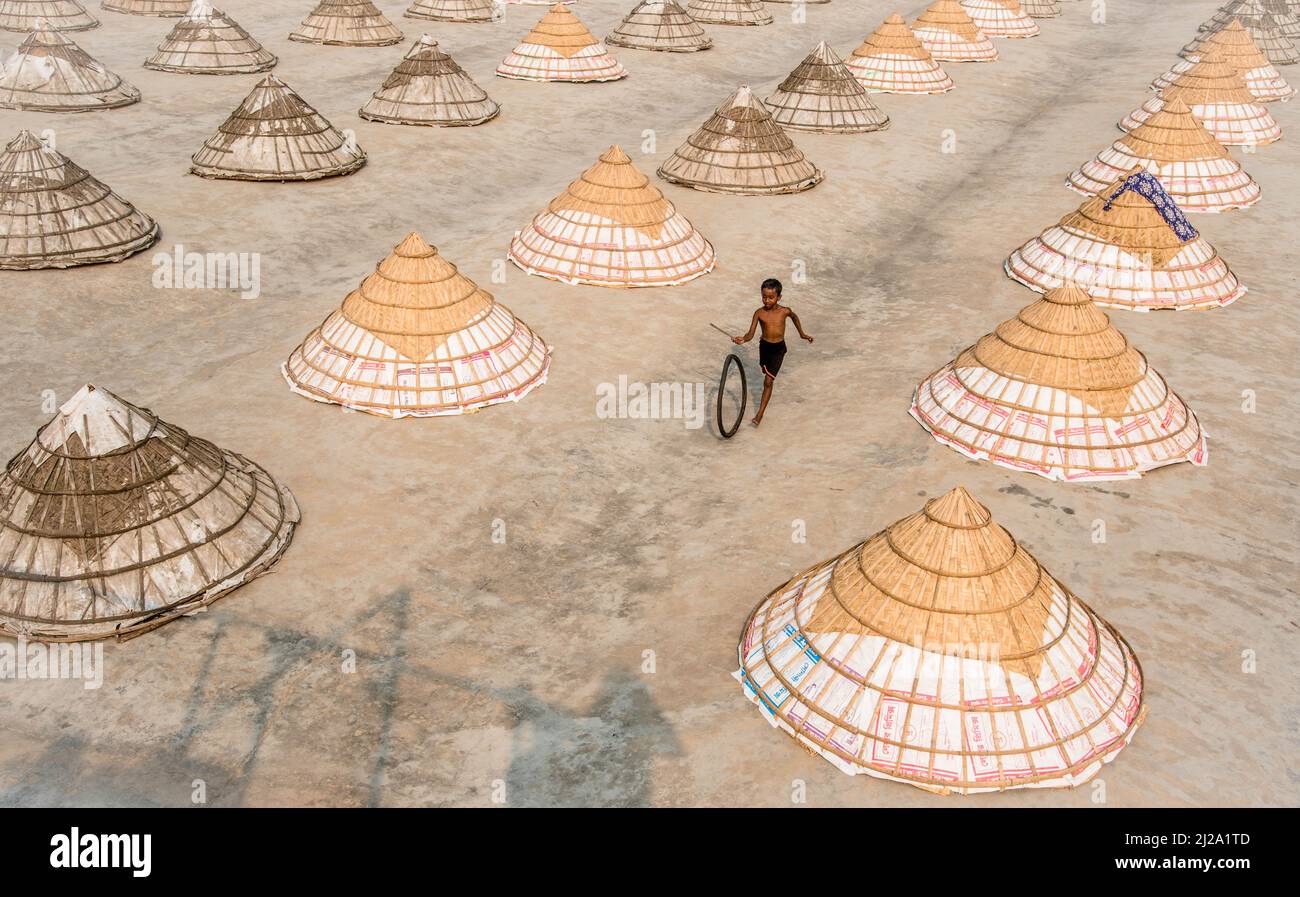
[190,75,365,181]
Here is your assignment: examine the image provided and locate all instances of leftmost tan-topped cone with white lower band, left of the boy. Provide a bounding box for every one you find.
[282,228,551,417]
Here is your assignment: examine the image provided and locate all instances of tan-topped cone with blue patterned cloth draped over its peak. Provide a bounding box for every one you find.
[1004,169,1245,312]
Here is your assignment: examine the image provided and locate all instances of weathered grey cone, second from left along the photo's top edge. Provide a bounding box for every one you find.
[144,0,276,74]
